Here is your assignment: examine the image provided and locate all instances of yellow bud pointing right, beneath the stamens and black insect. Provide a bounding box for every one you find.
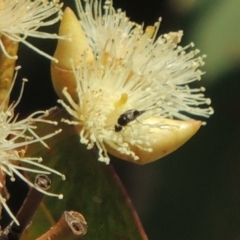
[106,118,201,165]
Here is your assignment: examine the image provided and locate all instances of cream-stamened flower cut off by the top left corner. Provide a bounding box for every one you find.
[0,0,65,61]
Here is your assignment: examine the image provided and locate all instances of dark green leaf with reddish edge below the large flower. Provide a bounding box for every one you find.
[22,109,147,240]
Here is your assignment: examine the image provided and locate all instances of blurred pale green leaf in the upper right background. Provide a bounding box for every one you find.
[192,0,240,83]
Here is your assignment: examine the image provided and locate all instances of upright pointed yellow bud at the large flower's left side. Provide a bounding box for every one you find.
[51,7,94,101]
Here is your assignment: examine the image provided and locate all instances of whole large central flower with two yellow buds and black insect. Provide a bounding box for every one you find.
[52,0,213,164]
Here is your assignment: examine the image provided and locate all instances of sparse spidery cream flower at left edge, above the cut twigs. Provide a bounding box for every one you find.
[0,67,65,223]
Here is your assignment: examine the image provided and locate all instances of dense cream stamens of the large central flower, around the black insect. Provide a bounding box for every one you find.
[59,0,213,163]
